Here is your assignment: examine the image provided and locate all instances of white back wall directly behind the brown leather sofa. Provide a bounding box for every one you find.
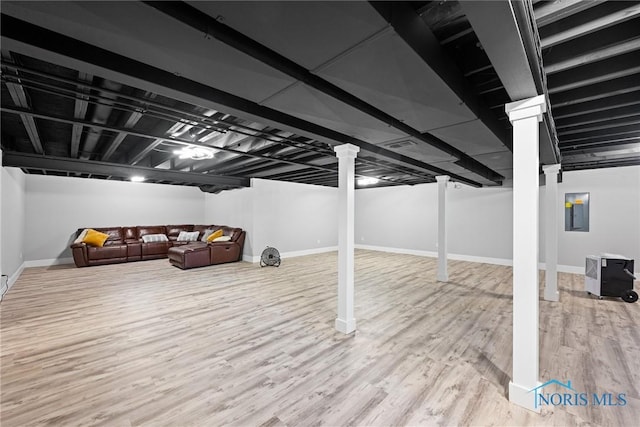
[23,175,205,265]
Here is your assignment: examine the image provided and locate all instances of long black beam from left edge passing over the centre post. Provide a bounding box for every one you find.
[0,14,482,187]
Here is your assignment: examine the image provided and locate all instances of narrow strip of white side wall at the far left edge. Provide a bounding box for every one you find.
[0,167,26,285]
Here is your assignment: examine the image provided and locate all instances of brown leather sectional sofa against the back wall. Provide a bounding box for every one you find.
[71,224,246,267]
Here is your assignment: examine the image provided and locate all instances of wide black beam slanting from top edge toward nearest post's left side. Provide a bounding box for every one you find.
[369,1,513,151]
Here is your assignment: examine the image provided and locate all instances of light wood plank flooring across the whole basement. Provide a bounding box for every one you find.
[0,250,640,427]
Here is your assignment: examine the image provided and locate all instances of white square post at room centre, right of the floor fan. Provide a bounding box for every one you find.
[334,144,360,334]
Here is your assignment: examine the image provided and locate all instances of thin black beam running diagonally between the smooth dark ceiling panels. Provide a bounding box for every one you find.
[144,1,504,184]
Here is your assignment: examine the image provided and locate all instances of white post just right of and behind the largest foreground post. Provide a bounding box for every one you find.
[542,165,560,301]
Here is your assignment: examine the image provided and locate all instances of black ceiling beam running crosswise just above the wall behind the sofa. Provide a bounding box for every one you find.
[2,152,249,187]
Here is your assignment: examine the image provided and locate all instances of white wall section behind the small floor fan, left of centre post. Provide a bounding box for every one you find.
[206,179,338,258]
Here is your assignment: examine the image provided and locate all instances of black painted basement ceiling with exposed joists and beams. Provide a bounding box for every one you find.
[1,1,640,192]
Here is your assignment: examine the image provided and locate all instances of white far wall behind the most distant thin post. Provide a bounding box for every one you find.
[355,183,513,263]
